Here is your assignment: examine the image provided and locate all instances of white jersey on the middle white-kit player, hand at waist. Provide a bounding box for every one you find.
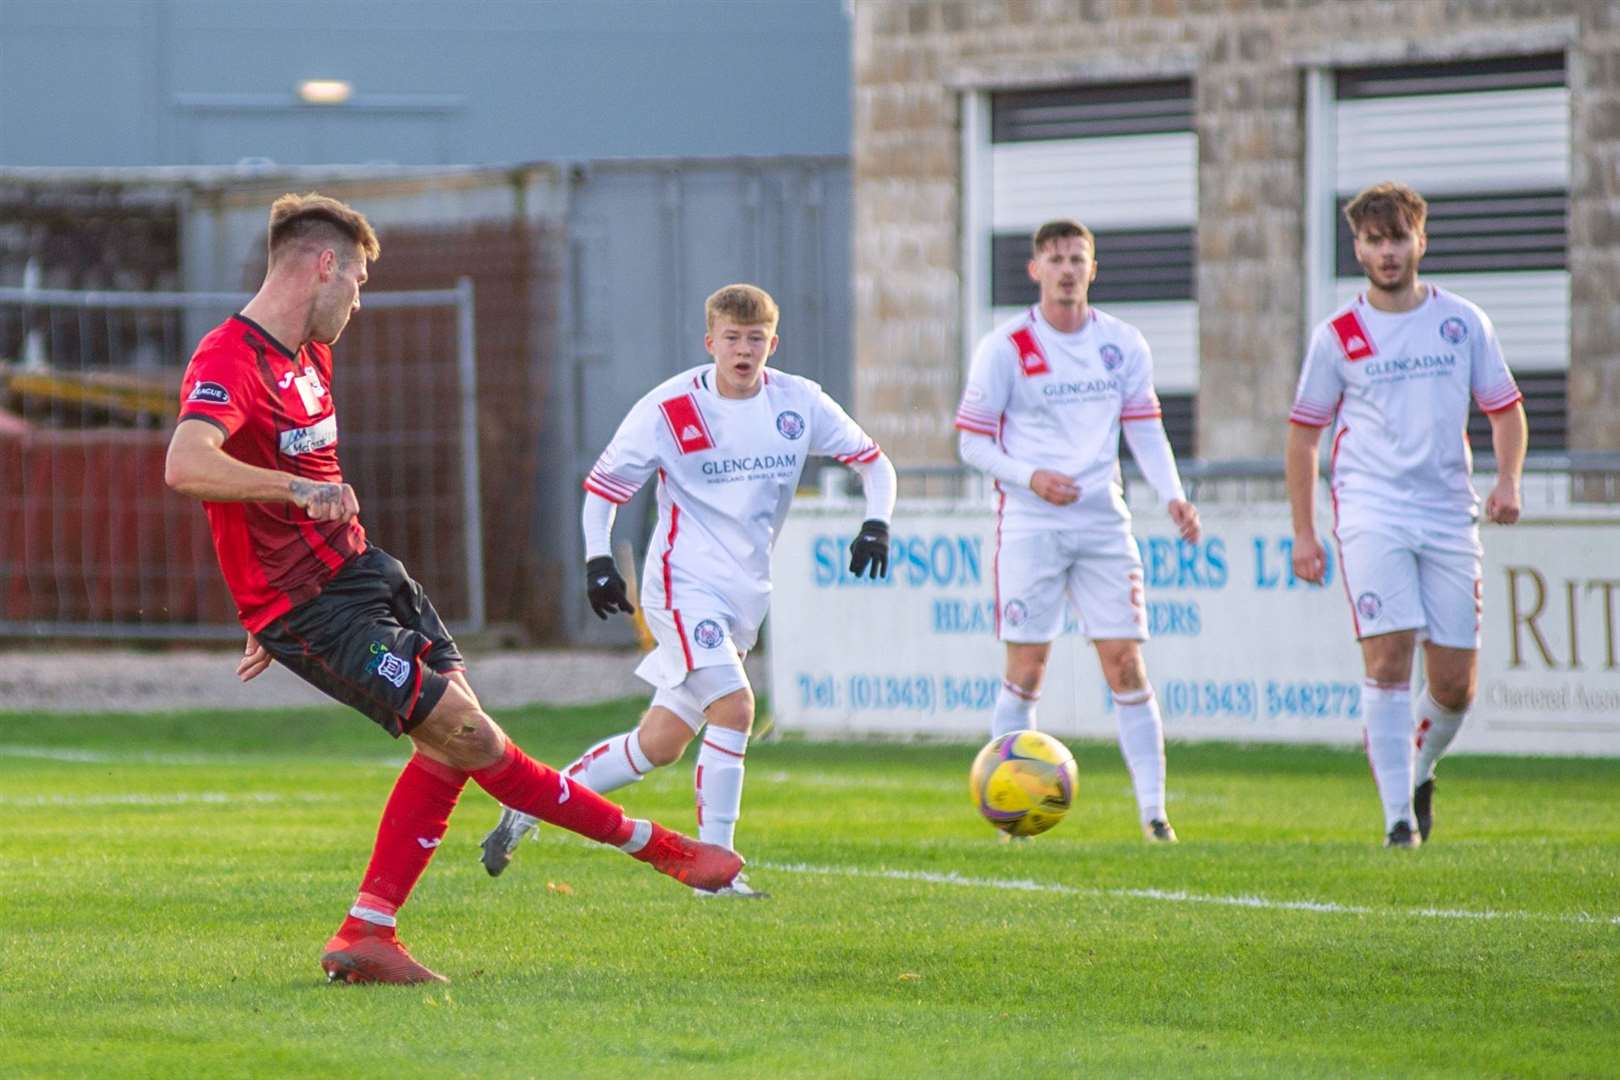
[956,306,1160,531]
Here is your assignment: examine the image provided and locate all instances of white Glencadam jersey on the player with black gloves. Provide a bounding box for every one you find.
[585,364,880,649]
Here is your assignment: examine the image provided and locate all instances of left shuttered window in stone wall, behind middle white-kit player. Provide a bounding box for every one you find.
[964,79,1199,455]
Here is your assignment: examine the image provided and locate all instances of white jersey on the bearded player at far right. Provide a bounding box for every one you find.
[1290,285,1523,521]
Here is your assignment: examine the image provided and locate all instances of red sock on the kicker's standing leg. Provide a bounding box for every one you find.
[355,755,467,921]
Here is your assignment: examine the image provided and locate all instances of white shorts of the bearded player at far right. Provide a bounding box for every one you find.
[1335,521,1484,649]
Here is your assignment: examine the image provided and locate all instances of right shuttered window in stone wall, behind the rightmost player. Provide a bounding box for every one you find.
[1307,53,1570,450]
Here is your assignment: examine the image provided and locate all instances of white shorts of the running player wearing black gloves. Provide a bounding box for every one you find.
[635,607,748,732]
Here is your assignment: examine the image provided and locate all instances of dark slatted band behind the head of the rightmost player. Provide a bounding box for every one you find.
[1334,191,1570,277]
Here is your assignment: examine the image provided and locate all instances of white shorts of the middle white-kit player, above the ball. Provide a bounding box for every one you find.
[995,529,1147,644]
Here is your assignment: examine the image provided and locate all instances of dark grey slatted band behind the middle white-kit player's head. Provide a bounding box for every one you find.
[990,227,1197,308]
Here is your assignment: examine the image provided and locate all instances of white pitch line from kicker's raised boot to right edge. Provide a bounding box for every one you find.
[753,863,1620,926]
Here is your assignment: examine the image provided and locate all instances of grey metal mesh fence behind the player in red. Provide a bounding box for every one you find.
[0,279,486,640]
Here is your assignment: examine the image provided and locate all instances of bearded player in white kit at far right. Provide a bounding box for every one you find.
[1286,183,1526,847]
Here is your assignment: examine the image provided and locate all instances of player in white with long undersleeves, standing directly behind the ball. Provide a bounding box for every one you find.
[956,220,1199,844]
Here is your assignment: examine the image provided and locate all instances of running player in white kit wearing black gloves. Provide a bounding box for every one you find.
[483,285,894,897]
